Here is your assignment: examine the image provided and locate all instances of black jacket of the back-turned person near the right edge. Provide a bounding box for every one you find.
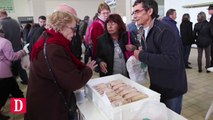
[194,21,212,48]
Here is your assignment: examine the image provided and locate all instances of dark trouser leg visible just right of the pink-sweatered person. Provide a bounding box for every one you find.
[12,60,28,83]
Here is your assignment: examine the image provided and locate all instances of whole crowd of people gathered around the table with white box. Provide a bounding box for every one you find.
[0,0,213,120]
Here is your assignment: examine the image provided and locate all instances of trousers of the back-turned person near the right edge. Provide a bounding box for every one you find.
[197,45,211,70]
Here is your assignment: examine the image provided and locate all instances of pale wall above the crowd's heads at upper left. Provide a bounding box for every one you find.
[9,0,126,22]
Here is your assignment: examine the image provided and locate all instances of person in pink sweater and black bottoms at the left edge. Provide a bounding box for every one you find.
[0,29,28,120]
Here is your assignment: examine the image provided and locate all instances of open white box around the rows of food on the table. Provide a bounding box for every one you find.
[85,74,160,120]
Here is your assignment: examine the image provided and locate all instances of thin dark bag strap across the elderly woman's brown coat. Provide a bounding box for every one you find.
[43,34,75,116]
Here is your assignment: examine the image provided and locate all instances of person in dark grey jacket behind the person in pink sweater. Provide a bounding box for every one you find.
[0,10,28,85]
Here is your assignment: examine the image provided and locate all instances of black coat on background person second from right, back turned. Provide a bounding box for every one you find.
[180,21,195,45]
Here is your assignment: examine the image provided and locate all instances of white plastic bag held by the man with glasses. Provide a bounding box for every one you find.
[126,56,148,84]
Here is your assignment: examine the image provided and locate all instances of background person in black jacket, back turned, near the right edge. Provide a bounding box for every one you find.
[194,12,212,73]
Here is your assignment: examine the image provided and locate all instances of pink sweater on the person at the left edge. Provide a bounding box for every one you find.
[0,37,25,78]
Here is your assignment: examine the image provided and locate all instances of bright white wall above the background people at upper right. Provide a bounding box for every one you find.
[164,0,212,27]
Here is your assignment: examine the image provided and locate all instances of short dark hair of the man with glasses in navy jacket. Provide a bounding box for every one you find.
[133,0,159,19]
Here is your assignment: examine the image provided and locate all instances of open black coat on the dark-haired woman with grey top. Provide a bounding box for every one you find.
[96,32,139,77]
